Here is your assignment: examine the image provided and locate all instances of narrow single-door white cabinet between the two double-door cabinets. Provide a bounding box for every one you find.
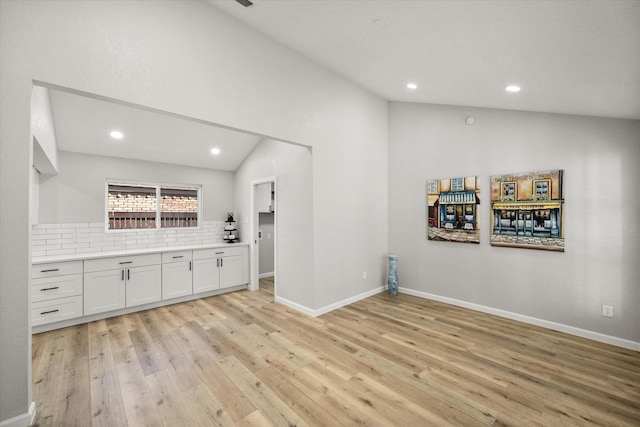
[162,251,193,299]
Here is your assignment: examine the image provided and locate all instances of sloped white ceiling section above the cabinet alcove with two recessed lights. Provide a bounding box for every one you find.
[49,89,261,171]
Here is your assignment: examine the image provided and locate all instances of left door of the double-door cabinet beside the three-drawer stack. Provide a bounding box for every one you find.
[84,269,126,316]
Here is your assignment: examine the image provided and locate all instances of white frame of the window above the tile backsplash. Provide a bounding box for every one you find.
[104,178,202,233]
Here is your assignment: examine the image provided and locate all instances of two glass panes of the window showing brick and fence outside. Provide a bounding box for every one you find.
[107,182,200,230]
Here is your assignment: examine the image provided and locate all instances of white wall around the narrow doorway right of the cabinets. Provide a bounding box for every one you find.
[235,140,314,308]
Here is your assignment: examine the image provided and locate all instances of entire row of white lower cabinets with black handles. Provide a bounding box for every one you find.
[31,245,249,331]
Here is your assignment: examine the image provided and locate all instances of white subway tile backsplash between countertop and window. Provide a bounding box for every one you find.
[31,221,225,257]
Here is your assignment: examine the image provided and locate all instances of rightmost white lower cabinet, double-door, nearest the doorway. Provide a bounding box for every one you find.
[193,246,249,293]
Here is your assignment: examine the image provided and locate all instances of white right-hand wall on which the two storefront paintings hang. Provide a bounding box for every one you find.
[389,103,640,343]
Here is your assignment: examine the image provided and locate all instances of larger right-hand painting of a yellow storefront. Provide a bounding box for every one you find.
[491,170,565,252]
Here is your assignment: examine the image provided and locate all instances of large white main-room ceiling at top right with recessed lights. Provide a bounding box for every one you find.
[209,0,640,119]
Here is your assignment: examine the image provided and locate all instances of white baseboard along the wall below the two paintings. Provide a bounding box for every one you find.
[399,287,640,351]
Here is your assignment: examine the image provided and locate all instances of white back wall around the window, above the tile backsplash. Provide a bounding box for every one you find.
[40,151,234,223]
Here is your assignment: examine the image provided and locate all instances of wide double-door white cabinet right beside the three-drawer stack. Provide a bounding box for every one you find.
[84,254,162,316]
